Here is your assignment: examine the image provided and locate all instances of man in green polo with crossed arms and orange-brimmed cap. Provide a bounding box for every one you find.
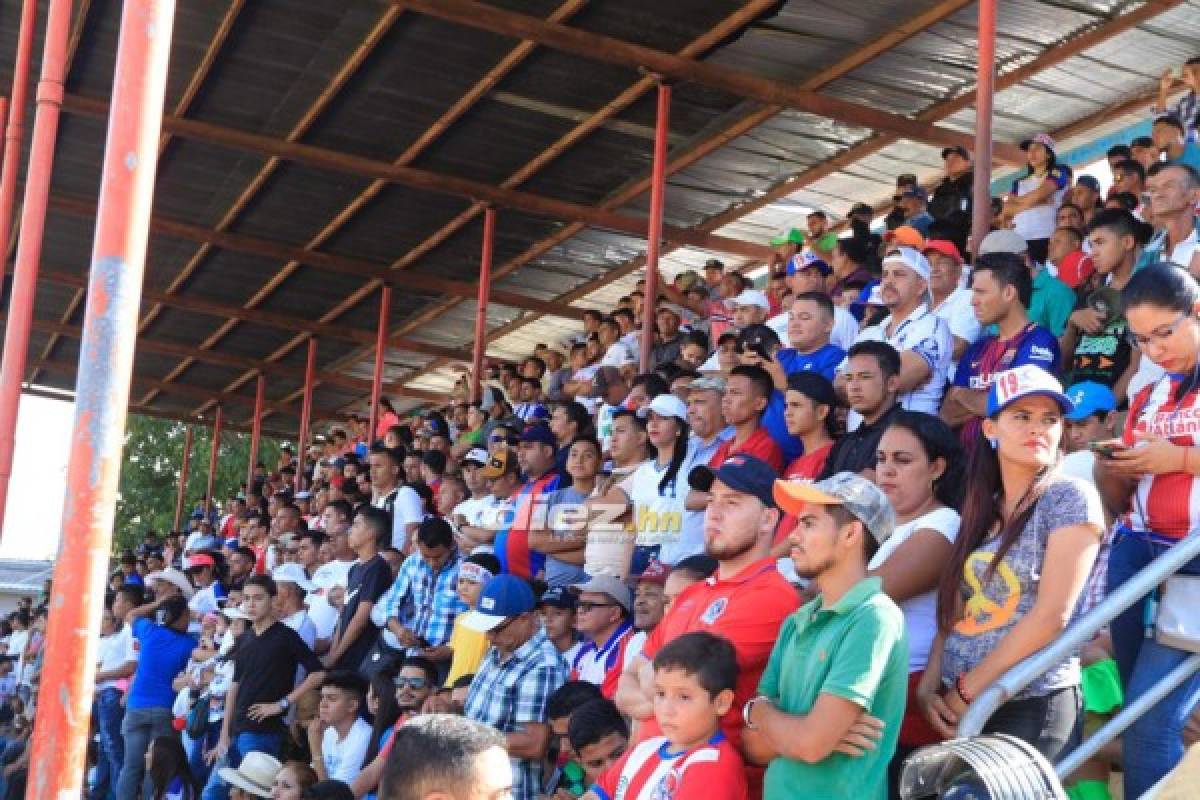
[743,473,908,800]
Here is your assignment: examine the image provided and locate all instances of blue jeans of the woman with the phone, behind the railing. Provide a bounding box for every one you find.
[1109,528,1200,798]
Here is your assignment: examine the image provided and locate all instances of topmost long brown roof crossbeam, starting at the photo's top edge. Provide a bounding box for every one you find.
[391,0,1025,165]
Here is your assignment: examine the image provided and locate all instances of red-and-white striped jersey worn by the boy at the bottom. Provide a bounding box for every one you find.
[592,732,748,800]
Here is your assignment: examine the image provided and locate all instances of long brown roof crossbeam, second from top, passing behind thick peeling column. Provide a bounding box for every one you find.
[62,94,770,259]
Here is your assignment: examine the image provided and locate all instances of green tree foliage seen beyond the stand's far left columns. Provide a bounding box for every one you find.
[113,414,287,552]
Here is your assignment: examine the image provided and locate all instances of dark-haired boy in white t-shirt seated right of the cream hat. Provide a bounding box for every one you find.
[308,669,371,783]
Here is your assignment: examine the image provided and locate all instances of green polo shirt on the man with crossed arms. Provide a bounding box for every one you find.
[758,578,908,800]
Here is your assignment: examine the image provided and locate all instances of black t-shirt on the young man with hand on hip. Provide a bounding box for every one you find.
[232,621,324,733]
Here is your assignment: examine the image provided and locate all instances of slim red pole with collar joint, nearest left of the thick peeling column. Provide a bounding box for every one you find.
[0,0,73,530]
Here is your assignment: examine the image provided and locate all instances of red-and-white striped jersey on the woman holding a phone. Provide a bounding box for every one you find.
[1122,375,1200,539]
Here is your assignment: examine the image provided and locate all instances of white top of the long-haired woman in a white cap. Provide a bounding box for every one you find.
[620,441,704,566]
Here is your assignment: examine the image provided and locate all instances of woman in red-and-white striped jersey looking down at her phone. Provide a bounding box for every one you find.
[1096,264,1200,798]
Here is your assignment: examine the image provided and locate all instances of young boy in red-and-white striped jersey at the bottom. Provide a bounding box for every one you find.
[583,631,748,800]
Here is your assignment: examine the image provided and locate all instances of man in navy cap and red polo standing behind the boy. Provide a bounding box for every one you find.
[616,455,799,796]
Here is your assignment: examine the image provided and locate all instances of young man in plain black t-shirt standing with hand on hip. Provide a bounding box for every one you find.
[204,575,325,800]
